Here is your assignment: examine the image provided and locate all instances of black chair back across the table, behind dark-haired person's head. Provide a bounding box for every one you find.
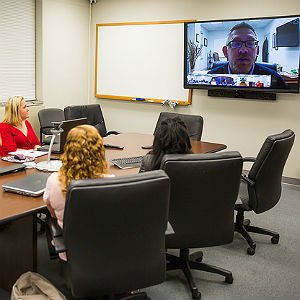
[154,112,203,141]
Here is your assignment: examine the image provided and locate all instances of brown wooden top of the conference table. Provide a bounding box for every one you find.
[0,133,226,224]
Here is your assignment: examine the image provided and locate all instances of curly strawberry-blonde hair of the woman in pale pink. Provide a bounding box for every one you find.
[58,125,107,192]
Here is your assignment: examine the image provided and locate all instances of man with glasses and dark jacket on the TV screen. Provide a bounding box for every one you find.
[208,22,287,88]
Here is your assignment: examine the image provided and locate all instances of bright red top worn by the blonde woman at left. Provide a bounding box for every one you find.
[0,120,41,156]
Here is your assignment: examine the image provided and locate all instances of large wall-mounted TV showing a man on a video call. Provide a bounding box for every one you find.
[184,16,300,93]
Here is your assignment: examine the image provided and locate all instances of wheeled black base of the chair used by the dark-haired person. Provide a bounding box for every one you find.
[166,249,233,300]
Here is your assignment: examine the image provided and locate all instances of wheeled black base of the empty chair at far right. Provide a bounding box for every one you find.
[234,210,279,255]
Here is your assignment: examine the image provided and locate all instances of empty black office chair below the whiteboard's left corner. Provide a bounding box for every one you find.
[64,104,120,137]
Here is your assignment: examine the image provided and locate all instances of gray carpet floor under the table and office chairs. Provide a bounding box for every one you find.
[0,184,300,300]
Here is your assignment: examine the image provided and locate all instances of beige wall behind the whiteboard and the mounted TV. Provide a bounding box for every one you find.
[90,0,300,179]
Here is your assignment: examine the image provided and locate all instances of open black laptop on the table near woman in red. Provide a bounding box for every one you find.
[38,118,87,154]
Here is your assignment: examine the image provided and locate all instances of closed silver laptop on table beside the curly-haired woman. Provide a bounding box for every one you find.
[2,172,50,197]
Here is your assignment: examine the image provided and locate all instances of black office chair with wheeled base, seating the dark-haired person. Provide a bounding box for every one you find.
[161,152,243,300]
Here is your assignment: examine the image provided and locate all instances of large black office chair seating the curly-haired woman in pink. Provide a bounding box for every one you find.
[50,170,170,300]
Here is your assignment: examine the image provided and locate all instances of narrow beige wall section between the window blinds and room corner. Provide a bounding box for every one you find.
[36,0,90,108]
